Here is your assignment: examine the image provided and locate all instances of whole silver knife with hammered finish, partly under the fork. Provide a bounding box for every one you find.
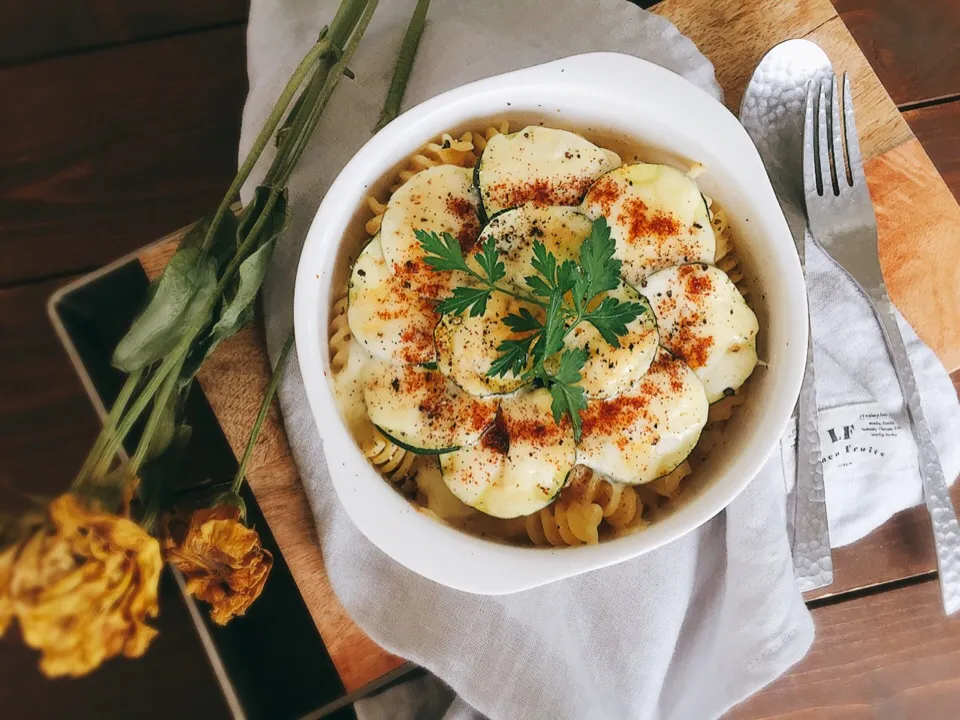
[740,40,833,592]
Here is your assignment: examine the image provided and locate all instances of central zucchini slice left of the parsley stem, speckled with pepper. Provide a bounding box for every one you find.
[434,293,542,396]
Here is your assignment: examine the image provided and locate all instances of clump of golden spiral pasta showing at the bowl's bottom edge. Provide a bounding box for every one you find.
[526,465,643,546]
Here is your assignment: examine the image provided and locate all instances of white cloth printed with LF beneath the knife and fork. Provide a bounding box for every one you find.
[782,236,960,547]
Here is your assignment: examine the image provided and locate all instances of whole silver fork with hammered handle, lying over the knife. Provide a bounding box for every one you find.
[803,73,960,615]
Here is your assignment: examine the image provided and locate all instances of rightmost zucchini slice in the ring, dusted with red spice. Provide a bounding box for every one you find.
[643,264,759,402]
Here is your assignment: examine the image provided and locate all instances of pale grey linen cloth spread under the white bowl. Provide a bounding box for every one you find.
[240,0,955,718]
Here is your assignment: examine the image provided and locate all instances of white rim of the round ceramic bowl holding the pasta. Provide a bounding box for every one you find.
[294,52,807,595]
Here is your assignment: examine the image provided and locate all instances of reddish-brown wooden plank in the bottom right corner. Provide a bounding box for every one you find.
[726,581,960,720]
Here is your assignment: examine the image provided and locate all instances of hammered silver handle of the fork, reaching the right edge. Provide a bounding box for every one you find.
[869,287,960,615]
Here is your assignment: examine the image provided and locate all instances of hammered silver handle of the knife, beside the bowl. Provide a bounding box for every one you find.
[793,318,833,592]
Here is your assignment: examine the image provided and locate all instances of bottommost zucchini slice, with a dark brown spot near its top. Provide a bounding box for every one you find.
[440,388,576,518]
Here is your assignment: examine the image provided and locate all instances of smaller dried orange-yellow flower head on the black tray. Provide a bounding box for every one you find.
[163,505,273,625]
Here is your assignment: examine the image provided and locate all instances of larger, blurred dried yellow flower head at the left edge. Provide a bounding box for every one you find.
[0,494,163,677]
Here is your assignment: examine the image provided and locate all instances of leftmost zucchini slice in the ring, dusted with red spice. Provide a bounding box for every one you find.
[347,235,440,365]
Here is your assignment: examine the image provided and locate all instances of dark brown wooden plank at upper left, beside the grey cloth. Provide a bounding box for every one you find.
[0,26,246,285]
